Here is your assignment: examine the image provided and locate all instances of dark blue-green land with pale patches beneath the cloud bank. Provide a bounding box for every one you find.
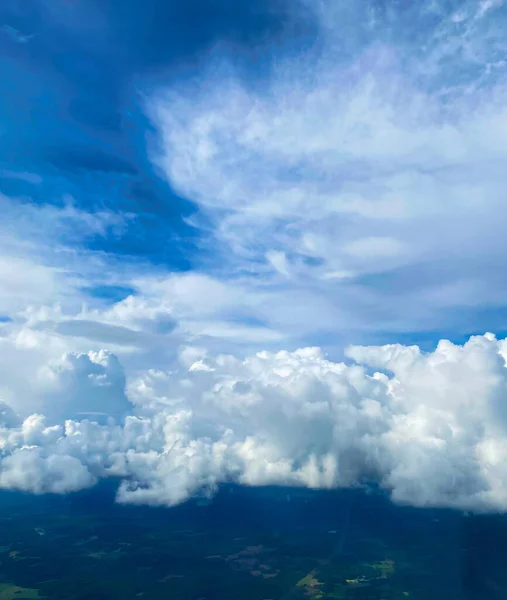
[0,486,507,600]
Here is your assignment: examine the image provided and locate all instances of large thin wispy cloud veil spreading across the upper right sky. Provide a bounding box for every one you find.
[147,0,507,347]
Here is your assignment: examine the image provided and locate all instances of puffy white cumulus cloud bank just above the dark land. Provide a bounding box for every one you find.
[0,334,507,511]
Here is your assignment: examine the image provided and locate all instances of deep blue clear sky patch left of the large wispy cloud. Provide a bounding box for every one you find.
[0,0,312,269]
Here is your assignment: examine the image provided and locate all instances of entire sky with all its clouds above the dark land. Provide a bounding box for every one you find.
[0,0,507,511]
